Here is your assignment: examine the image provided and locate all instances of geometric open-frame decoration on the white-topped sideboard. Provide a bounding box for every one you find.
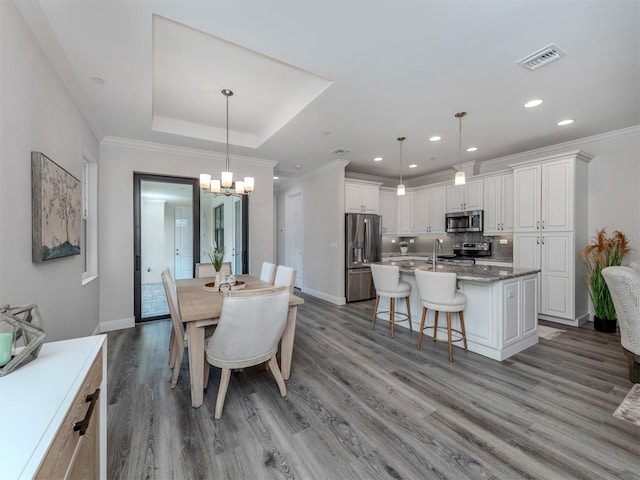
[0,305,47,377]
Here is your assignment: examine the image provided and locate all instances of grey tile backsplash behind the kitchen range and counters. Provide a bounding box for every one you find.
[382,233,513,261]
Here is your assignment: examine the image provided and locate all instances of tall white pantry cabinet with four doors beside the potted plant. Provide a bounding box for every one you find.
[512,151,592,326]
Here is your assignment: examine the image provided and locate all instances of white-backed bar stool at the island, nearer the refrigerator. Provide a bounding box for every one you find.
[371,265,413,337]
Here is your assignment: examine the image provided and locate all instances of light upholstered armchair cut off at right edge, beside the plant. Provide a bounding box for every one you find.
[602,267,640,383]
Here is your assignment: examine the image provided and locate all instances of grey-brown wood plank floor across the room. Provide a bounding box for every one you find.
[108,295,640,480]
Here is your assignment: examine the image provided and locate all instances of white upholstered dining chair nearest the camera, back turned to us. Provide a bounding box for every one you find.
[206,286,289,419]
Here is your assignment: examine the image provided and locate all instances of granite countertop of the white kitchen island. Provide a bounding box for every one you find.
[379,259,540,282]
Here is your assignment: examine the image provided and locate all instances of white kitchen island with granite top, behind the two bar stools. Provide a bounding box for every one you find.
[380,259,539,361]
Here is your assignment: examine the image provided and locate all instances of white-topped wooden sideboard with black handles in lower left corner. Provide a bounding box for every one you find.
[0,335,107,479]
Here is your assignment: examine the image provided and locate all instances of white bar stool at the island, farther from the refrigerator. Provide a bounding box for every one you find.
[414,268,468,362]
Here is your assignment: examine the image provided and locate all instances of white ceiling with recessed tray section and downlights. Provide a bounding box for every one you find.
[17,0,640,184]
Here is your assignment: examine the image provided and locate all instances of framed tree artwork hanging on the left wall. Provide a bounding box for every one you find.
[31,152,82,263]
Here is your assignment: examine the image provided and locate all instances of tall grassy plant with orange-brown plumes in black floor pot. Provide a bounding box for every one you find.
[582,228,631,333]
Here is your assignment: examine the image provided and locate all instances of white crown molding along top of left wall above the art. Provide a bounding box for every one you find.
[13,0,104,142]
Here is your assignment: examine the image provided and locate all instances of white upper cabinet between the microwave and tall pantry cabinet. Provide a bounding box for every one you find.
[484,173,513,235]
